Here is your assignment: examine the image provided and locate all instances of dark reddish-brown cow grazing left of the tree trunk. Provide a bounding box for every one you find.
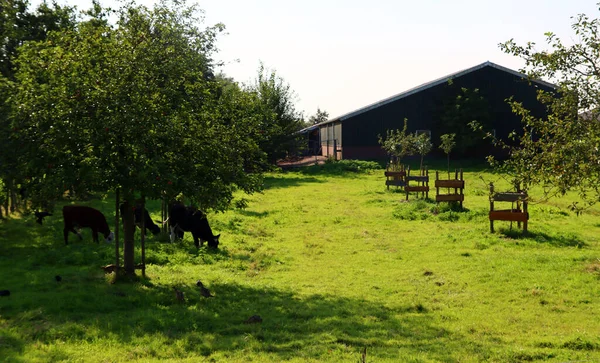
[63,205,115,245]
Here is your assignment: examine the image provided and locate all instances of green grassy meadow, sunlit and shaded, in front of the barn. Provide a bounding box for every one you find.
[0,163,600,362]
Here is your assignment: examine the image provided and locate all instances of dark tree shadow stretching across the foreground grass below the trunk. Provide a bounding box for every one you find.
[0,271,489,361]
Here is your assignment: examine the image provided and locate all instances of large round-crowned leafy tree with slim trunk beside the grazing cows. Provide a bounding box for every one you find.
[12,1,262,274]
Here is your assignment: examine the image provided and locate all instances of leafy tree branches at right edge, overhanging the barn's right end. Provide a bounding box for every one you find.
[500,3,600,211]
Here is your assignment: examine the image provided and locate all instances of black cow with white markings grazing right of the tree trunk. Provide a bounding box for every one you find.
[169,203,221,248]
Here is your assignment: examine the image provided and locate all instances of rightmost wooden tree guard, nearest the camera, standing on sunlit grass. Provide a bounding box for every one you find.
[489,183,529,233]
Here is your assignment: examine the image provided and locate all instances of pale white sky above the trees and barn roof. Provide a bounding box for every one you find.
[30,0,599,117]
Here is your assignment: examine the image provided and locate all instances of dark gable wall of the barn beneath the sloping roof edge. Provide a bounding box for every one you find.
[342,66,545,159]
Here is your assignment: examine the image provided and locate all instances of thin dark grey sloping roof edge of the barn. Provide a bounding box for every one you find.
[300,61,556,132]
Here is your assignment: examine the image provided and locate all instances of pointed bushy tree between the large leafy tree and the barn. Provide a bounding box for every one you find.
[247,63,304,164]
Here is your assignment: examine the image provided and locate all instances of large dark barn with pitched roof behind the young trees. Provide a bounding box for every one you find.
[303,62,555,159]
